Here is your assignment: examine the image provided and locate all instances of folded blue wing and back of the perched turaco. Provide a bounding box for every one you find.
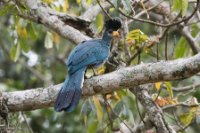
[67,40,109,74]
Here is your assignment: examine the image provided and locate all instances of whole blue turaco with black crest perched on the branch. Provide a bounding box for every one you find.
[54,19,121,112]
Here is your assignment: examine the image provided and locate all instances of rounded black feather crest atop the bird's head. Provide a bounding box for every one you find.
[105,18,122,31]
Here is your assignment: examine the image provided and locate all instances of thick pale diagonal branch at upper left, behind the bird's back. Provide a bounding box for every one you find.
[19,0,92,43]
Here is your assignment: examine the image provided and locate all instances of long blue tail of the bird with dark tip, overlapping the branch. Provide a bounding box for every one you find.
[54,68,86,112]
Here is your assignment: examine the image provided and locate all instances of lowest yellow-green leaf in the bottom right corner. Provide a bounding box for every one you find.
[179,112,194,125]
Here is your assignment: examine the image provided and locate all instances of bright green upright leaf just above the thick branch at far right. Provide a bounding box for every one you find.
[175,37,187,59]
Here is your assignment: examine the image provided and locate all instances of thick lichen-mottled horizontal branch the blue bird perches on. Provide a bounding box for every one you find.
[3,54,200,111]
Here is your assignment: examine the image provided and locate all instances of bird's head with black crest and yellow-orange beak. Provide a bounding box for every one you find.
[105,18,122,38]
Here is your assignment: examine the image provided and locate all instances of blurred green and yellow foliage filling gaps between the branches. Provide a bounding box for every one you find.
[0,0,200,133]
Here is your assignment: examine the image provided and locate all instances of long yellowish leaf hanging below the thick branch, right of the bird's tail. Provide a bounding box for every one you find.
[93,96,103,122]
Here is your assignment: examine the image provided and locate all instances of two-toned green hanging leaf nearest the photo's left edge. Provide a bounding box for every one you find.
[10,42,20,62]
